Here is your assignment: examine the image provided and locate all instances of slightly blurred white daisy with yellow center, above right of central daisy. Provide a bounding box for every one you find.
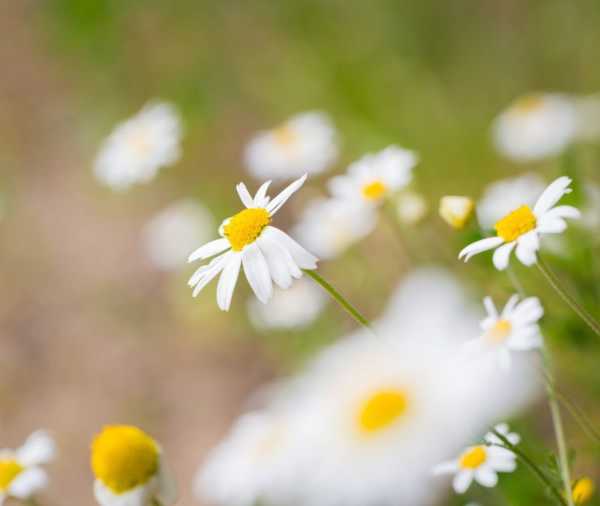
[329,146,418,205]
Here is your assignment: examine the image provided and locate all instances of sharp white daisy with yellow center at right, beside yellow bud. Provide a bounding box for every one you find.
[458,176,580,270]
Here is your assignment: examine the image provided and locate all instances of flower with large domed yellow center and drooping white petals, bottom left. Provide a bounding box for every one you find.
[91,425,177,506]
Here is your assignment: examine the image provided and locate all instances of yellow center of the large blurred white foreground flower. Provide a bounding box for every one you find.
[357,389,407,434]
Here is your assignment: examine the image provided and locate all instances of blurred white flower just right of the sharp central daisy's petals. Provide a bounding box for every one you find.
[294,199,377,259]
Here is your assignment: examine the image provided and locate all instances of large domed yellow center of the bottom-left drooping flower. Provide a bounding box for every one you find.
[91,425,159,494]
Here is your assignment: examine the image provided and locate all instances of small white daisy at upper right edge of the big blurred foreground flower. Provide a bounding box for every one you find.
[467,294,544,371]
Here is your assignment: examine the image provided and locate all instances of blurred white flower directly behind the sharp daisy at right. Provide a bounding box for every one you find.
[477,172,546,230]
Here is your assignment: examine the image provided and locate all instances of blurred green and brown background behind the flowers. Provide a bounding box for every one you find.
[0,0,600,506]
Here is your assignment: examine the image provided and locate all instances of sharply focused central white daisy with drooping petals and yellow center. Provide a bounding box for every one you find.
[188,175,317,311]
